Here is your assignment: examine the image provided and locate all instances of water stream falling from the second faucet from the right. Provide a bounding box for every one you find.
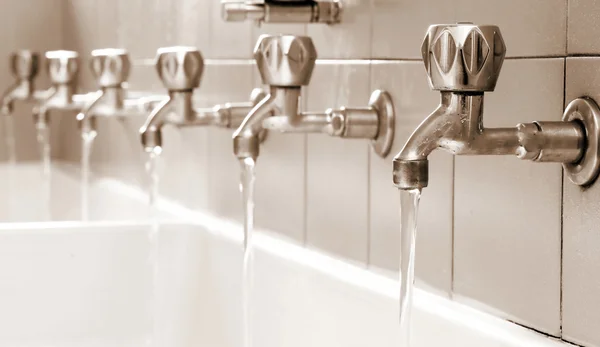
[240,158,256,347]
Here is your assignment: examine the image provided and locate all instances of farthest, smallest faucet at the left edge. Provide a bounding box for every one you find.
[0,50,49,116]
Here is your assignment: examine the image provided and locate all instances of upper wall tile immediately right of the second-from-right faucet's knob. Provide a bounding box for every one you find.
[306,0,372,59]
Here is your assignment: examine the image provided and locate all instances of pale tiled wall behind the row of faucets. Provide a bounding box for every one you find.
[9,0,600,346]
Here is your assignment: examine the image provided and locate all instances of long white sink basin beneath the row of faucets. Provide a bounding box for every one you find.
[0,215,566,347]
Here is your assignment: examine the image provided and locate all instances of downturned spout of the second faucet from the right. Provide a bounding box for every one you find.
[233,93,277,159]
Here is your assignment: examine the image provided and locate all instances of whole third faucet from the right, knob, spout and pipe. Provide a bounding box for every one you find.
[140,46,265,152]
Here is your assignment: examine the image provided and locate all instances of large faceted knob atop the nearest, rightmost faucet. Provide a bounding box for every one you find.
[421,23,506,92]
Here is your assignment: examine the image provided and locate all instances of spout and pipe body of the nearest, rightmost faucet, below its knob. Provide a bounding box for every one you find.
[393,92,586,190]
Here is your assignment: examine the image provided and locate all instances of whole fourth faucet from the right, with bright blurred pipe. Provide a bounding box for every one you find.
[77,48,166,133]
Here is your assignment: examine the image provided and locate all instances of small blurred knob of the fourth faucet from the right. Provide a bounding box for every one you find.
[90,48,131,87]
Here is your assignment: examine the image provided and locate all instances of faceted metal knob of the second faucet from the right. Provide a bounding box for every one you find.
[254,35,317,87]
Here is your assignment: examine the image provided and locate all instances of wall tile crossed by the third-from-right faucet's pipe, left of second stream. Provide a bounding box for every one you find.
[205,64,253,222]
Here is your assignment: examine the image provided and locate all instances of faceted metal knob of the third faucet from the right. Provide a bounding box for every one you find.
[156,46,204,91]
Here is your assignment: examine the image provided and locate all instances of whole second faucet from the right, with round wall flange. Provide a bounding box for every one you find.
[233,35,395,159]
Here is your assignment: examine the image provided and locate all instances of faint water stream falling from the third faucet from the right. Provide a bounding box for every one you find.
[146,147,162,347]
